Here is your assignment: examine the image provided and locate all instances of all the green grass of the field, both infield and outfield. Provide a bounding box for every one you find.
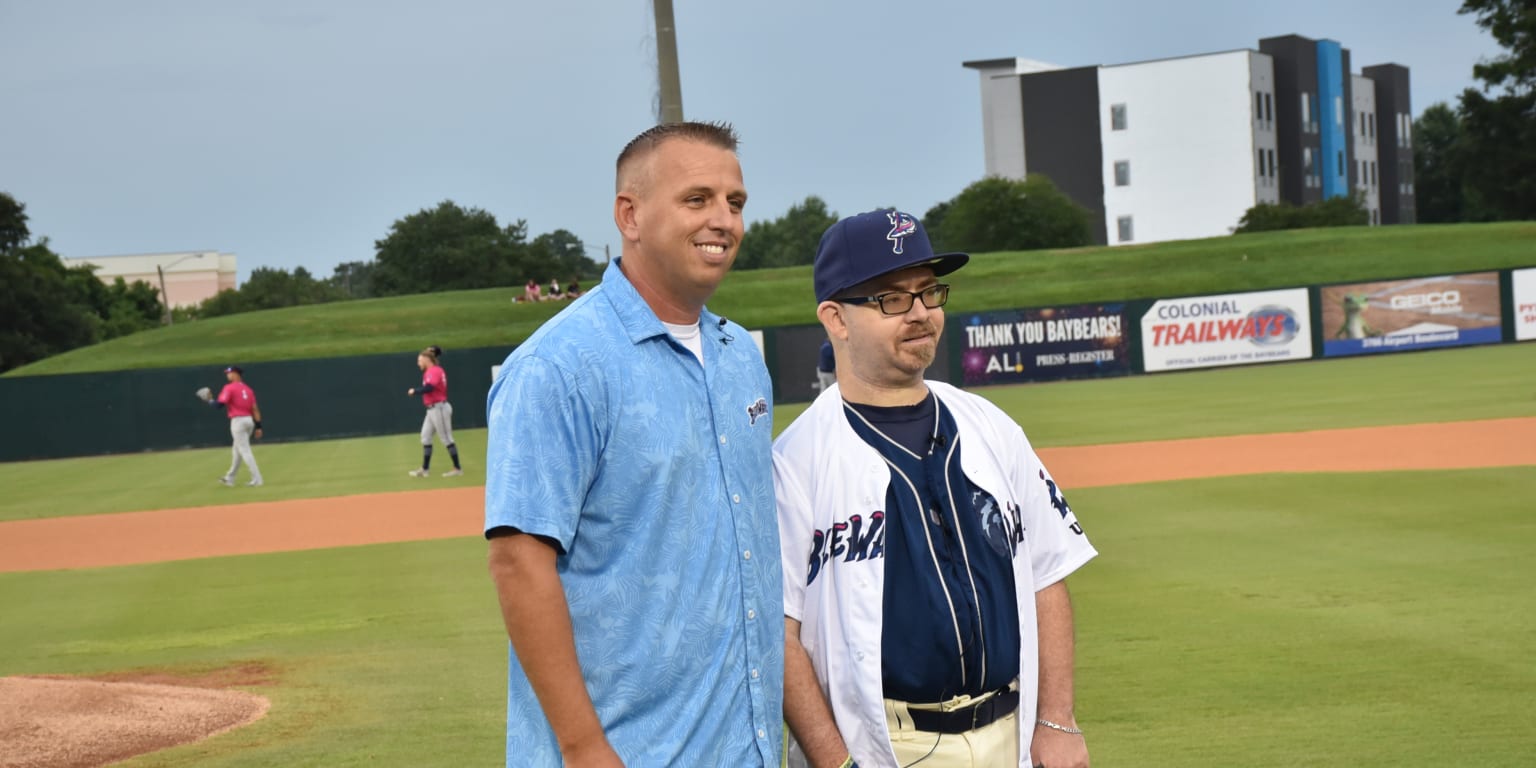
[0,344,1536,768]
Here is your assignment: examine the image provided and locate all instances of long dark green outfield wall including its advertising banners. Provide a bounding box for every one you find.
[0,267,1536,461]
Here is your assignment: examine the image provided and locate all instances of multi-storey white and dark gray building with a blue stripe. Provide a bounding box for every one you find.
[965,35,1413,244]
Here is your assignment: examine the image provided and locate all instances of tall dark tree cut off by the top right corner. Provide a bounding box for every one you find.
[1458,0,1536,218]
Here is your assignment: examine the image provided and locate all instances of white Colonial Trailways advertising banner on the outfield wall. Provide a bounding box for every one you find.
[1141,289,1312,373]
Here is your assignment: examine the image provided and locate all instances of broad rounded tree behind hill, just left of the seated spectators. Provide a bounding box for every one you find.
[373,200,528,296]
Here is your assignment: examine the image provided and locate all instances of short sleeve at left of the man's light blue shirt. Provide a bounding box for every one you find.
[485,356,601,551]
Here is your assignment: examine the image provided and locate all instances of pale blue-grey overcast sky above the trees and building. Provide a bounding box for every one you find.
[0,0,1499,280]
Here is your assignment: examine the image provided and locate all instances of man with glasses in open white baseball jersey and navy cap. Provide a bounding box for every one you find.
[773,210,1095,768]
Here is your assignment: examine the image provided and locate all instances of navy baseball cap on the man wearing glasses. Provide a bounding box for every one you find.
[811,209,971,303]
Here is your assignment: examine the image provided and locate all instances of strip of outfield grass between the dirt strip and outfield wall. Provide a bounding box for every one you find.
[0,344,1536,521]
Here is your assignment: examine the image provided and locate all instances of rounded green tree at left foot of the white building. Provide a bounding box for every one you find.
[925,174,1092,252]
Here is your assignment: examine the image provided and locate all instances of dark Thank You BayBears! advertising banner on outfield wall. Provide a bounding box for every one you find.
[945,304,1130,387]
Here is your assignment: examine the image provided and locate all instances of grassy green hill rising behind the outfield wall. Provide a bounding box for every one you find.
[8,221,1536,376]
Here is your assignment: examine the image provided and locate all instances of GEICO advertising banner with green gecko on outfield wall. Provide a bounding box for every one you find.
[1319,272,1504,358]
